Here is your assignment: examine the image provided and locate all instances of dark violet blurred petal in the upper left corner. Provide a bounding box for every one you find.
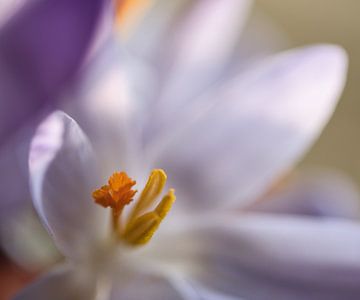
[0,0,107,143]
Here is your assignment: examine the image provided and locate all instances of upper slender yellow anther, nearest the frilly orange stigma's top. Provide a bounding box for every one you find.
[129,169,167,222]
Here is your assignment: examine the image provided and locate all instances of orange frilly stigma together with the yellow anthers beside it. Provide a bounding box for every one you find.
[92,169,175,246]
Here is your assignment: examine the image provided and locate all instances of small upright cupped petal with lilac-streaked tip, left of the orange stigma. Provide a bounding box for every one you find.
[29,112,106,257]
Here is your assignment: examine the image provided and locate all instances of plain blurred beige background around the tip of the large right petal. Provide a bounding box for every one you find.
[255,0,360,180]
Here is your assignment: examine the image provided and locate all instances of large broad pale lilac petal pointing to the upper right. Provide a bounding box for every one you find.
[152,45,346,209]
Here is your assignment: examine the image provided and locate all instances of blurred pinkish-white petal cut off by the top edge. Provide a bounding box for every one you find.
[164,0,251,79]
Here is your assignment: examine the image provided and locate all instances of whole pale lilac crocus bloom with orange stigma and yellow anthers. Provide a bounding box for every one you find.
[17,35,360,299]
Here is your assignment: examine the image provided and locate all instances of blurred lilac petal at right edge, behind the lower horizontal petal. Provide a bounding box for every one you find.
[249,170,360,219]
